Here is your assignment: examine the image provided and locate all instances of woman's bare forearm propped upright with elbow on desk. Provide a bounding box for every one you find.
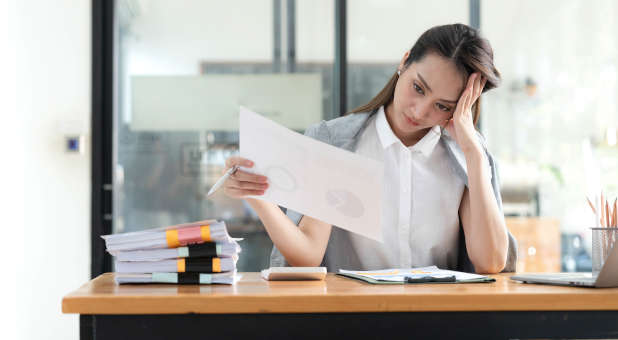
[459,149,509,273]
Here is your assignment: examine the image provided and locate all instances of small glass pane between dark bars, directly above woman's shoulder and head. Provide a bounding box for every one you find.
[347,0,469,110]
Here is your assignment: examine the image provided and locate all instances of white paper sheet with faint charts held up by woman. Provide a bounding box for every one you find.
[240,107,384,242]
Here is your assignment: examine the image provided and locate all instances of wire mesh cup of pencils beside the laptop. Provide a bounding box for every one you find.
[588,193,618,276]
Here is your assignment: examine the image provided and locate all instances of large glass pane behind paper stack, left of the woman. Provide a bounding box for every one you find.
[113,0,334,271]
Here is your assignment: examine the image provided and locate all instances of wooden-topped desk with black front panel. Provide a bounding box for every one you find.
[62,273,618,339]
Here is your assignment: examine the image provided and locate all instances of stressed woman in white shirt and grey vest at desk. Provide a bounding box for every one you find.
[225,24,516,273]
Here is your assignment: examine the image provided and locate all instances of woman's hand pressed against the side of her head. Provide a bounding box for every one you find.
[443,73,487,153]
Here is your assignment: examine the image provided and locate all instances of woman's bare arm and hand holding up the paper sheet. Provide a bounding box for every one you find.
[224,157,331,267]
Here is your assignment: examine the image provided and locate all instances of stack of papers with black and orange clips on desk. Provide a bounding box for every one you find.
[102,220,241,284]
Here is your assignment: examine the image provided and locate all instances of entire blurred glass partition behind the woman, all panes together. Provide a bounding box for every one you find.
[108,0,618,271]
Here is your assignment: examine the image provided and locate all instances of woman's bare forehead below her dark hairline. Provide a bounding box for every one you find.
[410,53,465,100]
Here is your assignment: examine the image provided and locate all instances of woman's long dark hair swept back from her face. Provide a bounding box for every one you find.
[349,24,501,125]
